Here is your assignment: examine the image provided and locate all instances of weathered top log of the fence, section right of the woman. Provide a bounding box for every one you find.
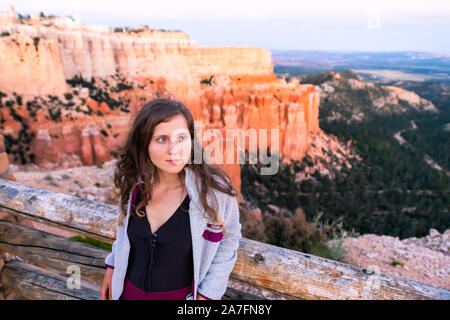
[230,238,450,300]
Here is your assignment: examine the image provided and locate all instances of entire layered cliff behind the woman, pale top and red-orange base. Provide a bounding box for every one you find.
[0,8,320,188]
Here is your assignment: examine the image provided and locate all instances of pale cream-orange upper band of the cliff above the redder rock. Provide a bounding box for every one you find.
[0,11,273,95]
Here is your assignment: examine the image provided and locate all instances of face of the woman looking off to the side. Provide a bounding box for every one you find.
[148,114,192,173]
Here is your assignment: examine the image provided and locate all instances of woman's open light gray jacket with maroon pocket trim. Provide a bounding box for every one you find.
[105,167,242,300]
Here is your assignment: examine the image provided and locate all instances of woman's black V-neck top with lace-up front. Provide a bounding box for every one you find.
[126,192,194,292]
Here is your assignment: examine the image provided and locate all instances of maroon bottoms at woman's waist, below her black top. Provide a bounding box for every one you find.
[119,278,192,300]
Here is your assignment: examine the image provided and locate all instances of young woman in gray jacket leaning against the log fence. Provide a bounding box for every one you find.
[101,99,241,300]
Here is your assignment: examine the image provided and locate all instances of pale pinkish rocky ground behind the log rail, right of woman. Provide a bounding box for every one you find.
[329,229,450,290]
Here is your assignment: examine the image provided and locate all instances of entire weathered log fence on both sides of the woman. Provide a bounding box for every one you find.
[0,179,450,300]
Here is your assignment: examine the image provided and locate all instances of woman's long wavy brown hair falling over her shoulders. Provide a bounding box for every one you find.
[114,98,239,232]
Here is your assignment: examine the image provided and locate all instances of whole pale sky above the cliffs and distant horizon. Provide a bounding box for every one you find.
[0,0,450,53]
